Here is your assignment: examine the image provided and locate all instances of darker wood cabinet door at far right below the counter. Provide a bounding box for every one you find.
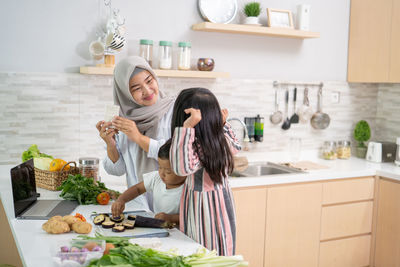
[375,179,400,267]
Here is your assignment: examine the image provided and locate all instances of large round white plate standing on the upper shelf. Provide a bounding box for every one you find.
[198,0,238,23]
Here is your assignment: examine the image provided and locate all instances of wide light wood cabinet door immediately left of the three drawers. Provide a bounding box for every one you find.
[264,184,322,267]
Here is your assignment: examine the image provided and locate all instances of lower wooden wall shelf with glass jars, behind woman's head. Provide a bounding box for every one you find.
[80,66,230,79]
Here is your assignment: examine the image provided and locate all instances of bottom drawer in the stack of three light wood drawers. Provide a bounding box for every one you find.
[318,235,371,267]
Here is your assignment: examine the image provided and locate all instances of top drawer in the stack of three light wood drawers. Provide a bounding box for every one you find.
[322,177,375,205]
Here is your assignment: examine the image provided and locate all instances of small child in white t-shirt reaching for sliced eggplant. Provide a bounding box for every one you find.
[111,139,186,224]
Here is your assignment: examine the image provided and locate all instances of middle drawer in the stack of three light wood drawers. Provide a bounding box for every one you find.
[321,201,373,240]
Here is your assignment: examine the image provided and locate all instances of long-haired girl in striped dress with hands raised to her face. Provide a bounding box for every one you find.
[170,88,240,255]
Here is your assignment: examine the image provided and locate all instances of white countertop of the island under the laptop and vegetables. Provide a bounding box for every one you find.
[0,165,200,267]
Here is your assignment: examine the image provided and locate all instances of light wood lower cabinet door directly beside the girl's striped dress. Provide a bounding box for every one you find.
[233,188,267,266]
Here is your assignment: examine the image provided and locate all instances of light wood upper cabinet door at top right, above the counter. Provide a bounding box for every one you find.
[347,0,392,82]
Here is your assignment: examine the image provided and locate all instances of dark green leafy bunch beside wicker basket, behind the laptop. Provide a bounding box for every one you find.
[57,174,119,205]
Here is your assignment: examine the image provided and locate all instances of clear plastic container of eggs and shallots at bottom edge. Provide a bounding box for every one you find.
[52,240,106,267]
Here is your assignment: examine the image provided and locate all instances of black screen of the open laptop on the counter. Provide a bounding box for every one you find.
[10,159,37,217]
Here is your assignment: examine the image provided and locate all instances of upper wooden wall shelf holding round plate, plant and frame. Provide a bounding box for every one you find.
[192,22,319,39]
